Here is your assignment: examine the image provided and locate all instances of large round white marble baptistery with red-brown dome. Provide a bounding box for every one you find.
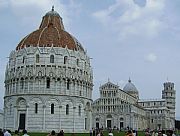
[4,8,93,132]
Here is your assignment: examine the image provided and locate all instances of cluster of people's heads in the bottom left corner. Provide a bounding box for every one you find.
[0,130,29,136]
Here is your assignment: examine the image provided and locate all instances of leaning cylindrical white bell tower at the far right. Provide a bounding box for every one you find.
[162,82,176,128]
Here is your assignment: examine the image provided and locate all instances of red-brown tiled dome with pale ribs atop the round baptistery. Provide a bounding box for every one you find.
[16,7,84,52]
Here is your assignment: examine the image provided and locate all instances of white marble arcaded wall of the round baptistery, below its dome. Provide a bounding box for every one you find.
[4,47,93,132]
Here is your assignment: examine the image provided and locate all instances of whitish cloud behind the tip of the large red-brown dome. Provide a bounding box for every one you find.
[0,0,81,29]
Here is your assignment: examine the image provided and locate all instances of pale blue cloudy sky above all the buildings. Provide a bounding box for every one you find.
[0,0,180,119]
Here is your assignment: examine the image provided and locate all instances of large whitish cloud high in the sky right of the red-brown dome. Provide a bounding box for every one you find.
[92,0,165,39]
